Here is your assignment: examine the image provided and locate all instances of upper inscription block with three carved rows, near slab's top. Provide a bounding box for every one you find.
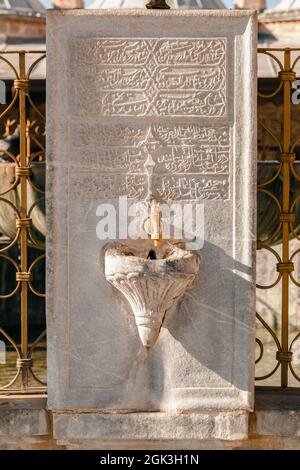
[77,38,226,117]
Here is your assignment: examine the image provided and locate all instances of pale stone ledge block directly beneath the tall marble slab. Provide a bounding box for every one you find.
[53,411,248,442]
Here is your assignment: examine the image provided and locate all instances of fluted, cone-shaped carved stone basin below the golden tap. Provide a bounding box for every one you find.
[105,242,200,348]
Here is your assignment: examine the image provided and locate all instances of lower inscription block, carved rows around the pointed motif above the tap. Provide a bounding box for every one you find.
[71,123,230,200]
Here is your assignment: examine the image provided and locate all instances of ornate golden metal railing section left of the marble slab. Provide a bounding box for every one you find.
[0,51,46,393]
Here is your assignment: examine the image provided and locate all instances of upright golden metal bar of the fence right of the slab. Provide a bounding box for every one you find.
[281,49,291,387]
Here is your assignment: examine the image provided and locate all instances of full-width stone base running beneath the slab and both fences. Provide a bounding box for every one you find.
[0,388,300,450]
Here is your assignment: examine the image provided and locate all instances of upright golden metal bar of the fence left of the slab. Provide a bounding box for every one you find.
[19,52,28,389]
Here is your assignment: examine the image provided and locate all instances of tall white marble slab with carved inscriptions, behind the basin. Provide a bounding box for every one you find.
[47,9,257,440]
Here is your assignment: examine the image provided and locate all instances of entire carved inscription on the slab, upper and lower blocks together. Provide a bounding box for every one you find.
[75,38,231,200]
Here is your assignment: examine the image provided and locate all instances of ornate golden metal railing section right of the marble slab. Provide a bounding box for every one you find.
[256,48,300,388]
